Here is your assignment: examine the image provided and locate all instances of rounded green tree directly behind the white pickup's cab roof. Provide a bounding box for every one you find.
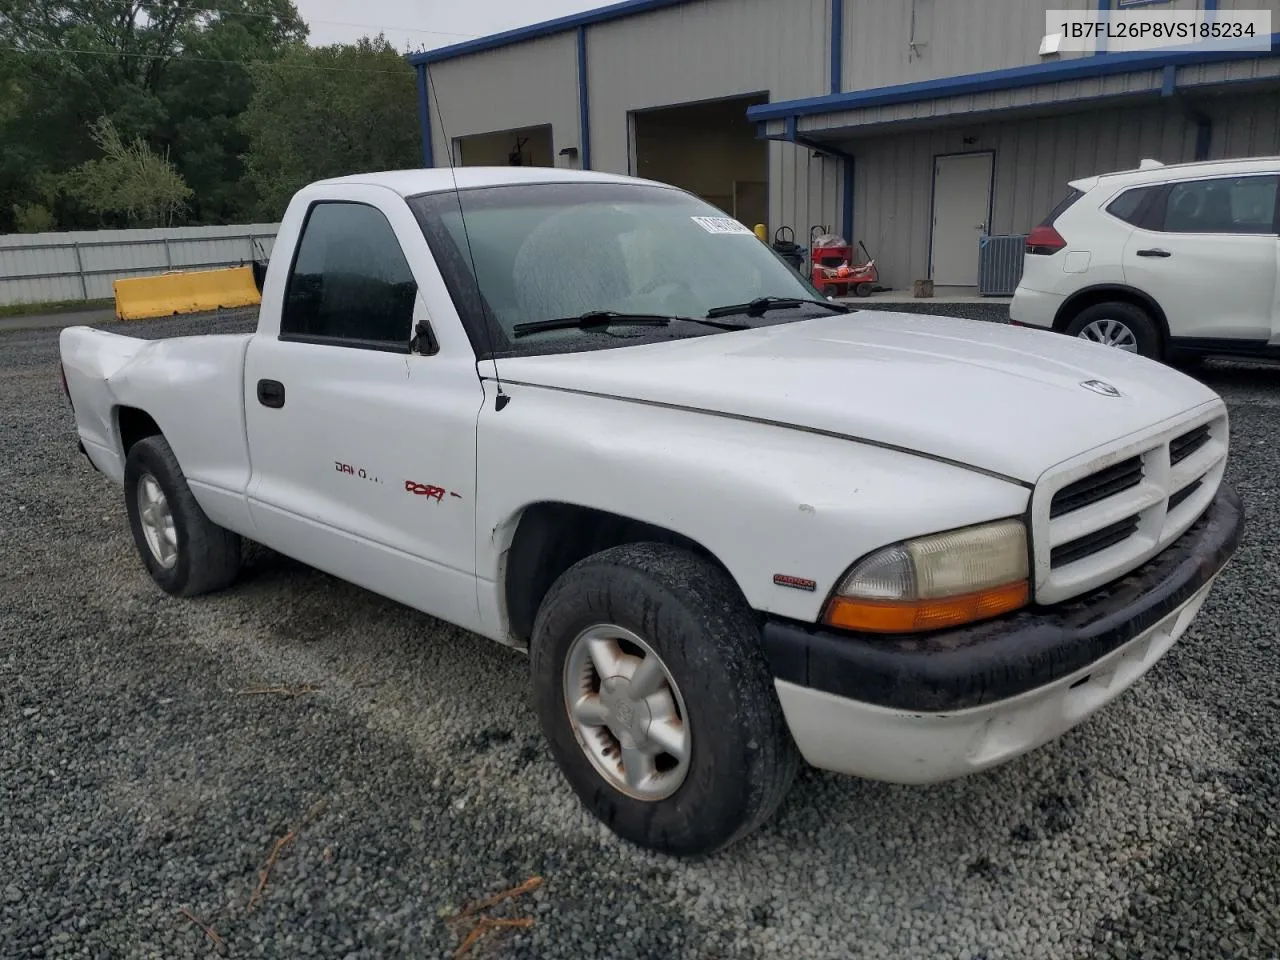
[242,35,421,221]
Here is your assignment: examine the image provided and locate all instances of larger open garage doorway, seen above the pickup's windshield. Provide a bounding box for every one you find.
[631,93,769,227]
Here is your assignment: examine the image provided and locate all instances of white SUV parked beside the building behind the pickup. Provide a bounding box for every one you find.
[1009,157,1280,361]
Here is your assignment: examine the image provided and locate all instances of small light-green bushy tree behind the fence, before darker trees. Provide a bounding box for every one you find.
[64,116,192,227]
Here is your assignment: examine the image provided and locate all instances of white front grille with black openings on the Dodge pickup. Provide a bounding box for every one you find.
[1032,406,1228,603]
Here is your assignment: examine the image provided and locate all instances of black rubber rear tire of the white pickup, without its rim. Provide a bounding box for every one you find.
[124,435,242,596]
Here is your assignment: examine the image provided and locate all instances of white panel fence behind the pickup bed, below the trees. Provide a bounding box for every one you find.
[0,224,279,306]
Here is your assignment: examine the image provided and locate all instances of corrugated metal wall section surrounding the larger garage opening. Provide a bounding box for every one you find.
[588,0,841,239]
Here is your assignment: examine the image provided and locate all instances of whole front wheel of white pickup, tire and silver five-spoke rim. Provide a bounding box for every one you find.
[531,544,799,856]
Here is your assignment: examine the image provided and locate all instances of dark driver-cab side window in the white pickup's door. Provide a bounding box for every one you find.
[280,201,417,349]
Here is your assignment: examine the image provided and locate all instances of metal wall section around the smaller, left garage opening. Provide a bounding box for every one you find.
[428,31,579,166]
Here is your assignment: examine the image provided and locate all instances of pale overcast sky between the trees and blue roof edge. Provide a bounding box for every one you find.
[293,0,599,50]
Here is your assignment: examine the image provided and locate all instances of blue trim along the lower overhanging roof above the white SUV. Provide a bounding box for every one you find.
[746,33,1280,123]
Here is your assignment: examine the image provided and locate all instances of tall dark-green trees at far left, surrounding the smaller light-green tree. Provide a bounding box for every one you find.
[0,0,307,232]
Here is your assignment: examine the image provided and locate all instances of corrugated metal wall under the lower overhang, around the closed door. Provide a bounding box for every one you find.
[845,93,1280,289]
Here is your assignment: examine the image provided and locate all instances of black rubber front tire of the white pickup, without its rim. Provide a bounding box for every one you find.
[530,543,800,856]
